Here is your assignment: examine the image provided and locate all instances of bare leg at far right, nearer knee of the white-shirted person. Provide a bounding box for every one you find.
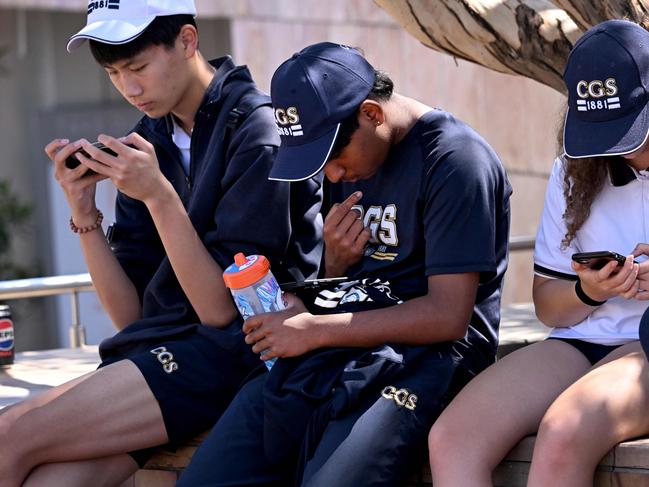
[528,342,649,487]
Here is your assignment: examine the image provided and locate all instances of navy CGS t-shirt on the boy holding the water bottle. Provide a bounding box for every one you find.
[330,110,512,362]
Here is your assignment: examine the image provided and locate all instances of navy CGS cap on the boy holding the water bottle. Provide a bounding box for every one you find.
[269,42,374,181]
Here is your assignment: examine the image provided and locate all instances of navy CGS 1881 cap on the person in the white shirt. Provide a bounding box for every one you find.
[563,20,649,158]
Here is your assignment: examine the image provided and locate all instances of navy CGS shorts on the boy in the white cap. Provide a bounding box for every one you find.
[100,325,260,466]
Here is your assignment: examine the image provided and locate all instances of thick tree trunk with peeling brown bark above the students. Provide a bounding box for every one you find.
[374,0,649,93]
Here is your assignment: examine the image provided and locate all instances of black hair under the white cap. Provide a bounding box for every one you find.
[90,14,196,66]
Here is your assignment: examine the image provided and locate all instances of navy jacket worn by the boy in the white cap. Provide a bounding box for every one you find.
[100,56,322,362]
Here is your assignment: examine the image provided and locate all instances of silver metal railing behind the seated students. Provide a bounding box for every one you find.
[0,235,534,348]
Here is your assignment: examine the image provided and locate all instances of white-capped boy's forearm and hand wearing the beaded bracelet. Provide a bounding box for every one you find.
[45,139,142,330]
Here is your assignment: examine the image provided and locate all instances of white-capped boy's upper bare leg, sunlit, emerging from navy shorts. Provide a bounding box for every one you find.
[0,360,168,487]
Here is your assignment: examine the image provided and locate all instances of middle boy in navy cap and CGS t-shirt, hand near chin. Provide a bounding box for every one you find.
[178,43,511,487]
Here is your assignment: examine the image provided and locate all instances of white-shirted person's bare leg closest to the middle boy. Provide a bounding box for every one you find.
[428,340,590,487]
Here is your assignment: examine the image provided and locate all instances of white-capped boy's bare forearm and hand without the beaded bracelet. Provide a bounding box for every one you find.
[76,133,236,327]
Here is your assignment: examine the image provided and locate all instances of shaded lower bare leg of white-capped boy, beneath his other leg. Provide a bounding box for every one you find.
[22,453,138,487]
